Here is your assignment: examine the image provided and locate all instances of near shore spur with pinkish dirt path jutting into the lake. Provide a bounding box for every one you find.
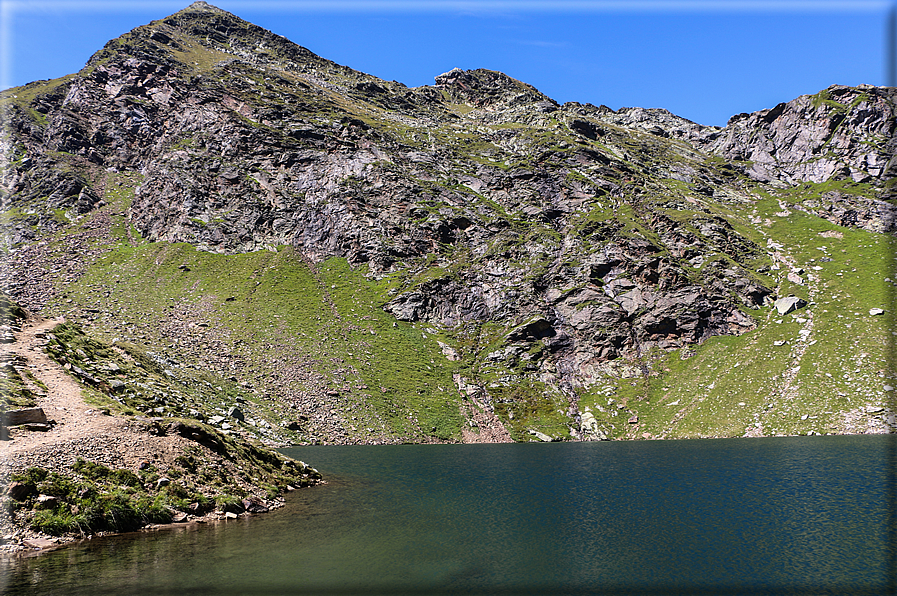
[0,312,320,554]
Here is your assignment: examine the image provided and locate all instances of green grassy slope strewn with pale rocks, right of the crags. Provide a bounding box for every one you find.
[580,184,897,438]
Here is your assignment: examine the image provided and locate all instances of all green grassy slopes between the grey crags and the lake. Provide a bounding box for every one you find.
[24,163,894,441]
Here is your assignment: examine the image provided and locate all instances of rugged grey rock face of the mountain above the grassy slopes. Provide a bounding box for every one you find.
[0,2,897,442]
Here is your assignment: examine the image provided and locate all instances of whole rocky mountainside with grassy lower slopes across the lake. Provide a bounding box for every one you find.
[0,2,897,444]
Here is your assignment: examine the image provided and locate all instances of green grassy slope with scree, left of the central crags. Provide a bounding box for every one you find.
[33,169,461,441]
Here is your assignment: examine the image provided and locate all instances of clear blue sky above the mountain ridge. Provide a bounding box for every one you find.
[0,0,894,126]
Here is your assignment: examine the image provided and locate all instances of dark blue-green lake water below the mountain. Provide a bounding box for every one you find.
[0,436,897,595]
